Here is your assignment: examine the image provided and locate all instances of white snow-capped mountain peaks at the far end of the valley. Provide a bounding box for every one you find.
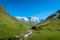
[16,16,40,23]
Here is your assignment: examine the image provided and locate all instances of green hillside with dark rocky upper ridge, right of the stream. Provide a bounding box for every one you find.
[28,10,60,40]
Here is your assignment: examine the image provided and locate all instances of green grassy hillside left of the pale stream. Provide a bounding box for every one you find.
[0,6,27,40]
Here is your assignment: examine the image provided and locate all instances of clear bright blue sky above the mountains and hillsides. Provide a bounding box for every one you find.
[0,0,60,19]
